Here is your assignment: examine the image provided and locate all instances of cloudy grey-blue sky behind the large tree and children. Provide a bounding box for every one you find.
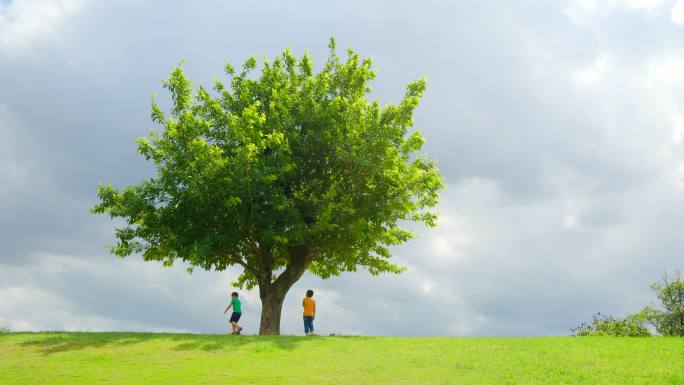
[0,0,684,336]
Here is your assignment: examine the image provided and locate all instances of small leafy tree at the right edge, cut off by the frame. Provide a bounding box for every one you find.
[640,272,684,336]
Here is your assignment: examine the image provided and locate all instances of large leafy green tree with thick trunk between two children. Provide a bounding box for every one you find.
[93,39,443,334]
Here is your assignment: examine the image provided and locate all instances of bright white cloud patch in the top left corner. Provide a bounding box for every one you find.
[0,0,86,54]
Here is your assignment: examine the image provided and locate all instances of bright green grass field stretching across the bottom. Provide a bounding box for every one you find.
[0,333,684,385]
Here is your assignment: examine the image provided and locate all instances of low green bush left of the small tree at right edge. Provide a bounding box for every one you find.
[570,313,651,337]
